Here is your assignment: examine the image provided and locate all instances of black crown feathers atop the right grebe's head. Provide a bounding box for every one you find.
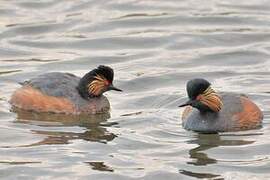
[187,79,211,100]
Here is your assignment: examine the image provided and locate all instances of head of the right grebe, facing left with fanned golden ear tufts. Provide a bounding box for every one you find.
[179,79,223,112]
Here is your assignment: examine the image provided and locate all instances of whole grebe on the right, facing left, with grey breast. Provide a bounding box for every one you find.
[179,79,263,133]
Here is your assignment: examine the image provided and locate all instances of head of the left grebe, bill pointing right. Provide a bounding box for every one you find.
[77,65,122,99]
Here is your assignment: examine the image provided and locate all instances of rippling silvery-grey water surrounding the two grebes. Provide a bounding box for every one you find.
[0,0,270,180]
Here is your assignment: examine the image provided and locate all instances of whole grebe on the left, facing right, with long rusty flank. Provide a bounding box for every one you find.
[10,65,121,114]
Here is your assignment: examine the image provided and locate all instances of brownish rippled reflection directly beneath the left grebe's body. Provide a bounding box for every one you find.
[14,109,116,146]
